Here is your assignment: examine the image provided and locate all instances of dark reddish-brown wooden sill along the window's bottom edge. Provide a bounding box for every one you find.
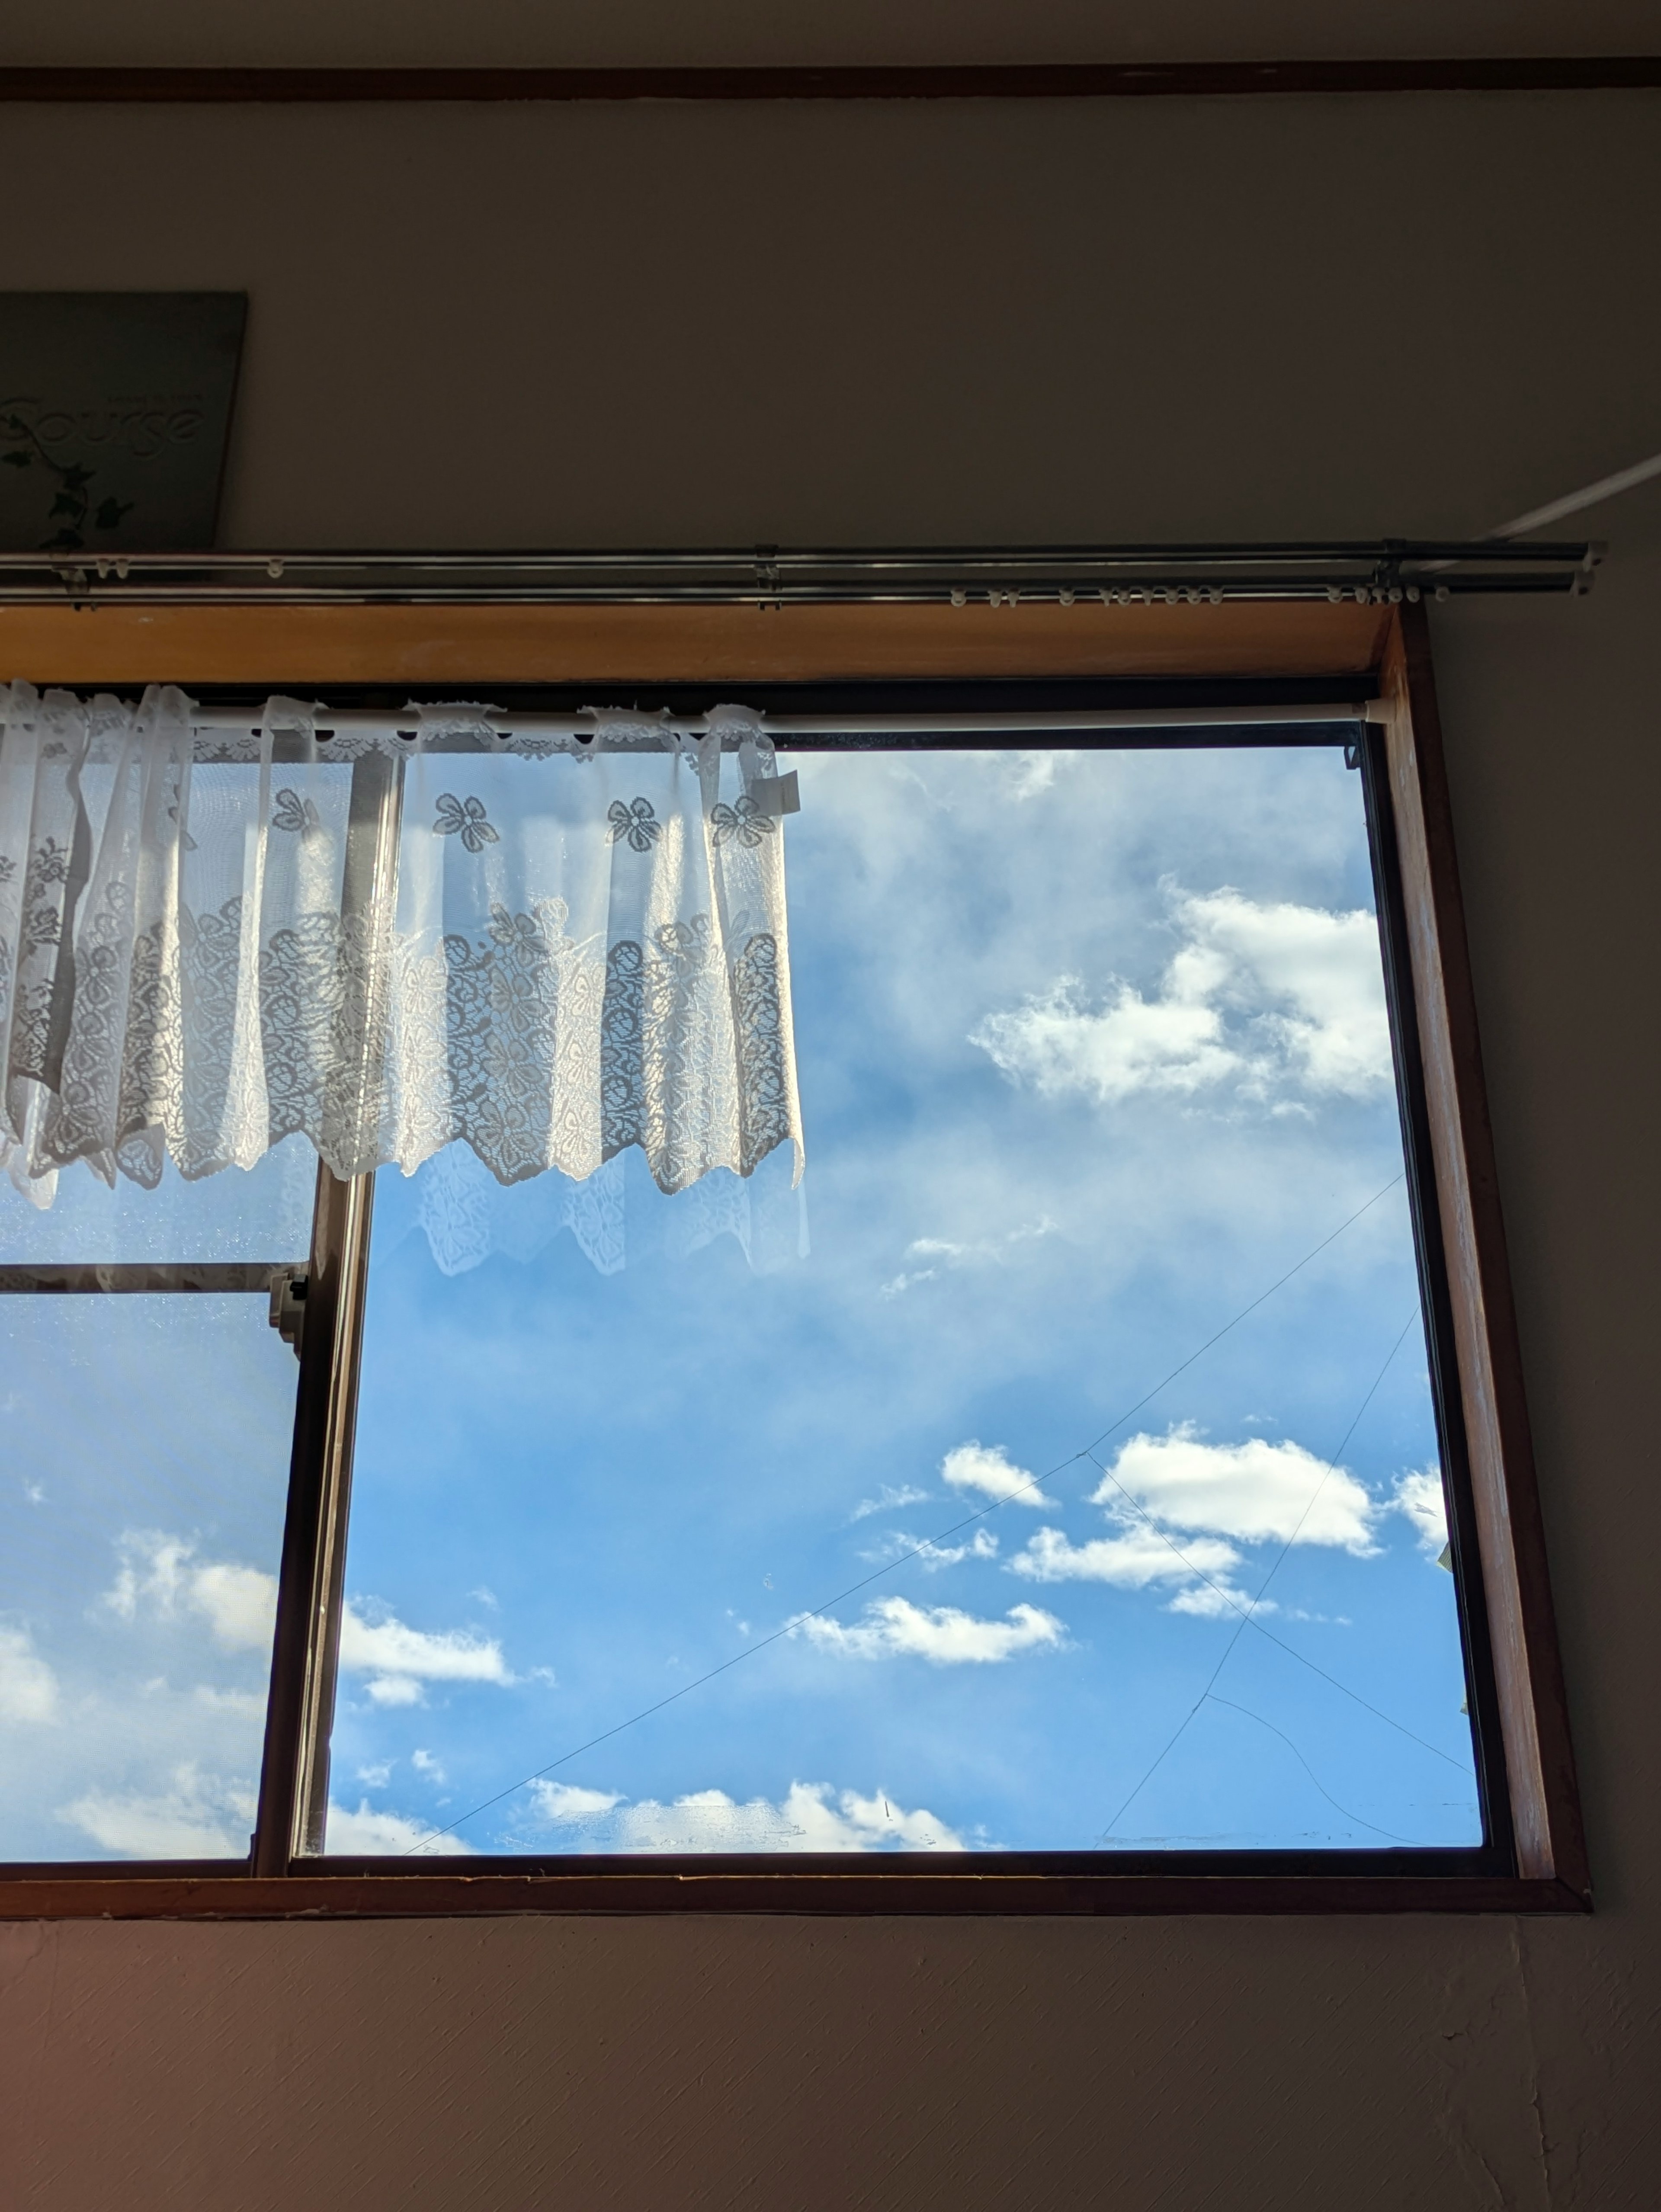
[0,1865,1586,1920]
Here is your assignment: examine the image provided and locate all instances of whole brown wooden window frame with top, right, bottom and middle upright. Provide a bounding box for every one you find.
[0,602,1590,1920]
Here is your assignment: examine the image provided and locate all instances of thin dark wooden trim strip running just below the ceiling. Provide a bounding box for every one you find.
[0,53,1661,104]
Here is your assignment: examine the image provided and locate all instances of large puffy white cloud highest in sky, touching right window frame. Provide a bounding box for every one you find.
[969,889,1391,1104]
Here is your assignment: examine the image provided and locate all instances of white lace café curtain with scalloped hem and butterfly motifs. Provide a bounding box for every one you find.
[0,683,803,1230]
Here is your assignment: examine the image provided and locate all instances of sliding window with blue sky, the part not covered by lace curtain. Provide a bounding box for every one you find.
[0,597,1584,1911]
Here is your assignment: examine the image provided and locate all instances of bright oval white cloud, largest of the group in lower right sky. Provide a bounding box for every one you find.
[1093,1422,1378,1555]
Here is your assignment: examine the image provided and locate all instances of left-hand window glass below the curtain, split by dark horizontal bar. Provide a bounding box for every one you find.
[0,1146,316,1860]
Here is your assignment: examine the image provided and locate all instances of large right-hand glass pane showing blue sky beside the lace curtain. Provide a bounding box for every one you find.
[327,745,1482,1854]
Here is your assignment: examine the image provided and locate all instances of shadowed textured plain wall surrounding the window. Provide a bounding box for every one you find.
[0,95,1661,2212]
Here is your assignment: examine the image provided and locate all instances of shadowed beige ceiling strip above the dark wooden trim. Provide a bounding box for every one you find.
[0,0,1661,64]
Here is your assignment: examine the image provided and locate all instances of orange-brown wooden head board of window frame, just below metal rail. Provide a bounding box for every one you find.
[0,599,1391,690]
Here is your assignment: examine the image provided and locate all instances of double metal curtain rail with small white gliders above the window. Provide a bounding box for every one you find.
[0,538,1603,606]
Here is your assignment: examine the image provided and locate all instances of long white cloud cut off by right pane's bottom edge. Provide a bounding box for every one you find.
[535,1783,964,1851]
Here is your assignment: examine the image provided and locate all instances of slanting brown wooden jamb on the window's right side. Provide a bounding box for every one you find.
[1382,606,1590,1898]
